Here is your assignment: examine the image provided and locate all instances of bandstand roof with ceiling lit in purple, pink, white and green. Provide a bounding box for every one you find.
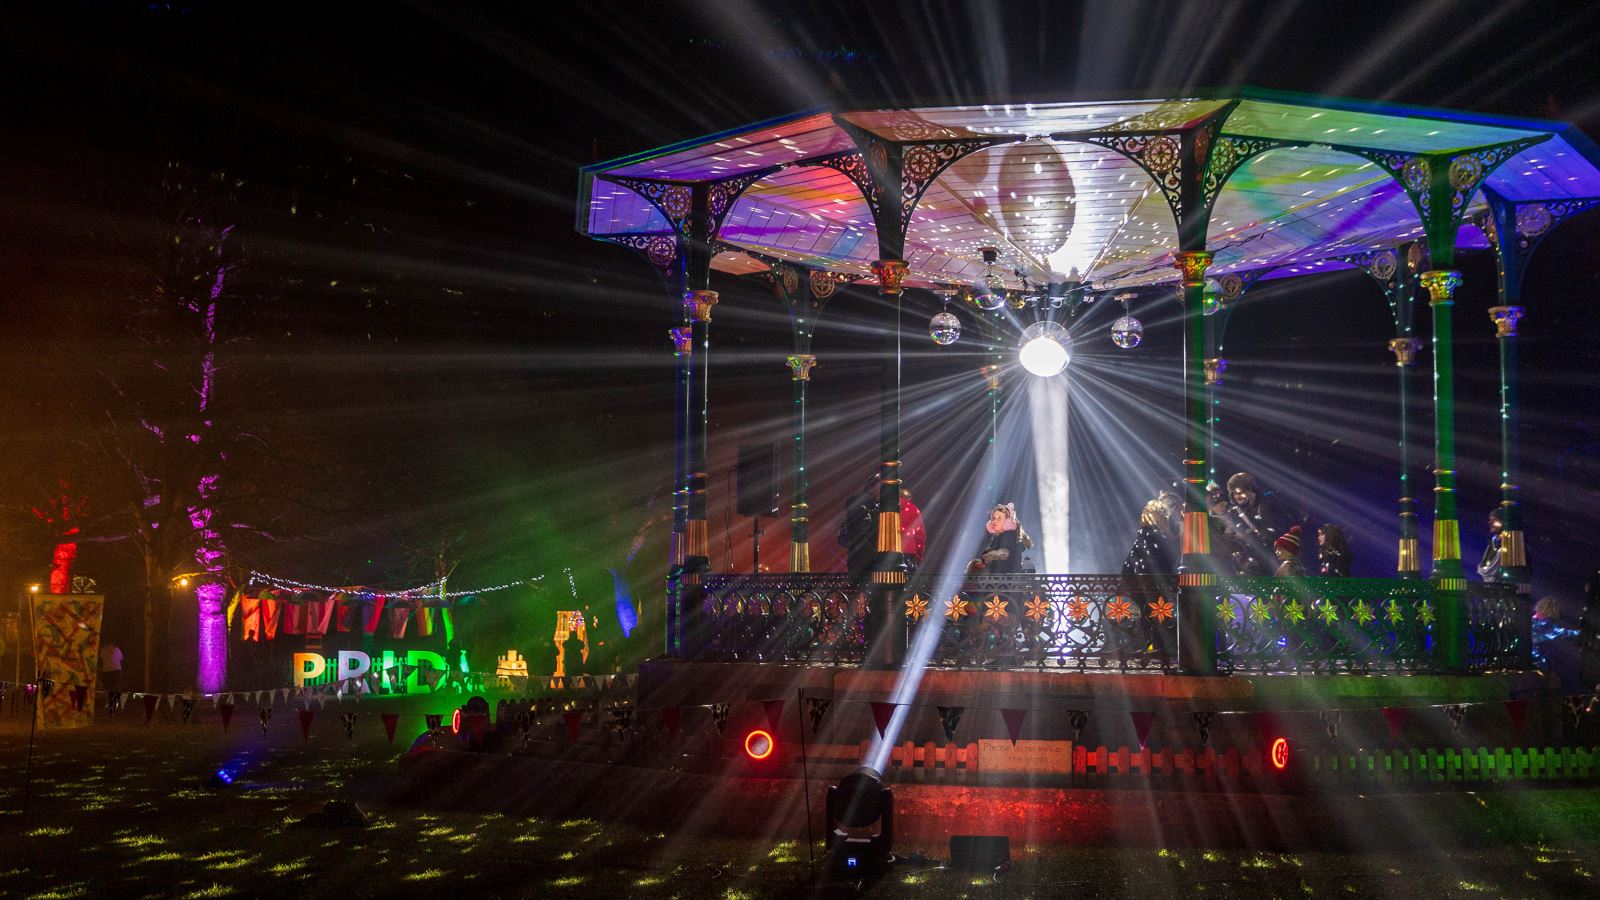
[578,88,1600,288]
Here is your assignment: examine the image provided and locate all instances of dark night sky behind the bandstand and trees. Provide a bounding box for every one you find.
[0,2,1600,659]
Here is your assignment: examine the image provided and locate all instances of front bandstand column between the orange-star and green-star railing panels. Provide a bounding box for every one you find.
[1174,250,1218,674]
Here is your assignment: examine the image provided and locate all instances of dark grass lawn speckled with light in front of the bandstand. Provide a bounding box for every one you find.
[0,706,1600,900]
